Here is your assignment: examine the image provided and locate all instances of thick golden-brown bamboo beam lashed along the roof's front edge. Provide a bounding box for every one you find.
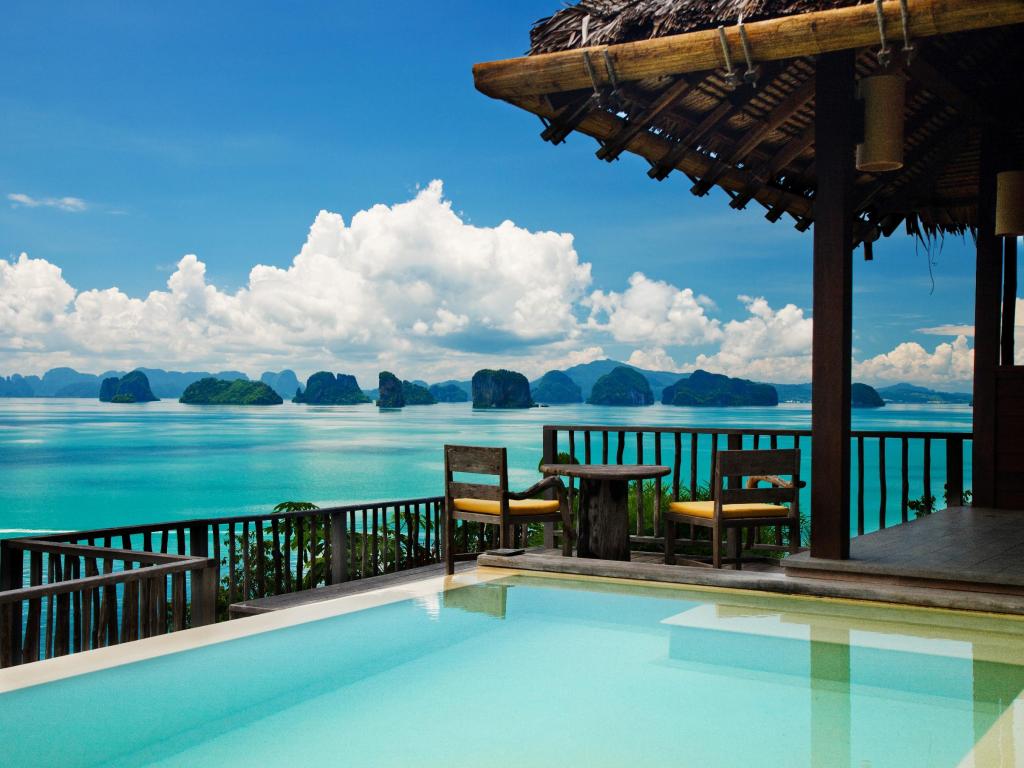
[473,0,1024,100]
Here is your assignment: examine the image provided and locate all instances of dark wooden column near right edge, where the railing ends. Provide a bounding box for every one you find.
[971,125,1002,507]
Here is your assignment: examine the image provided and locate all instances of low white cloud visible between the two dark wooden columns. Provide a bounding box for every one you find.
[853,335,974,389]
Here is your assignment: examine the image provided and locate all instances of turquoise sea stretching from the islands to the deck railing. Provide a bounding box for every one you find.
[0,398,972,538]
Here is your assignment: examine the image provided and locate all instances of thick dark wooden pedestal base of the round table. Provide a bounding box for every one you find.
[577,479,630,560]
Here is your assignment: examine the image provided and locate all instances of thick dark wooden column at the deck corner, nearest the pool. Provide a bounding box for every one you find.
[811,51,857,559]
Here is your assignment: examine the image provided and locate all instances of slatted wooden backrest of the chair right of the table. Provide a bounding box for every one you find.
[715,449,800,515]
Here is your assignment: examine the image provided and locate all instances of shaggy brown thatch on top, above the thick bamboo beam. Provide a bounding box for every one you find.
[529,0,856,53]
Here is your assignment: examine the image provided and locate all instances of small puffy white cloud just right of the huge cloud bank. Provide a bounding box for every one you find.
[588,272,722,346]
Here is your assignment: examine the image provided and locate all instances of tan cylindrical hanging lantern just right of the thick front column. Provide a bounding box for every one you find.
[857,75,906,173]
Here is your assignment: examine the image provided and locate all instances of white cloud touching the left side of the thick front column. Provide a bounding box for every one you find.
[687,296,812,383]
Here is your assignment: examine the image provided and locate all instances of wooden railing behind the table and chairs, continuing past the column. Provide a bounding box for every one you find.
[543,425,971,545]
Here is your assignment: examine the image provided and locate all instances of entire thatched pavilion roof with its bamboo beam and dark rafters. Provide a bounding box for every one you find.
[474,0,1024,241]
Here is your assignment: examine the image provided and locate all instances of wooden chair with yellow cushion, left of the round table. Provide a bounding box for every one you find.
[444,445,574,574]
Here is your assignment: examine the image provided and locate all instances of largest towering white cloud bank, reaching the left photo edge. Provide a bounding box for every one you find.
[0,182,591,378]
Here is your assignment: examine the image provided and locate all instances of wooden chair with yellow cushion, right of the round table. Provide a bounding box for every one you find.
[665,449,805,568]
